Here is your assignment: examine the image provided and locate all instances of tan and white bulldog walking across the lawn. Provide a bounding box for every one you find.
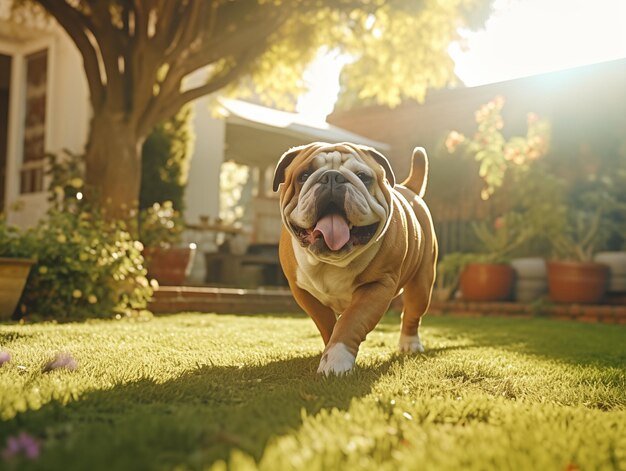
[273,142,437,376]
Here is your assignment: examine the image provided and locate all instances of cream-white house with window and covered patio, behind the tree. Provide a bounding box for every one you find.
[0,9,387,284]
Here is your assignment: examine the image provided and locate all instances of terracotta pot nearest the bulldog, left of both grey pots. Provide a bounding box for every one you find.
[460,263,515,301]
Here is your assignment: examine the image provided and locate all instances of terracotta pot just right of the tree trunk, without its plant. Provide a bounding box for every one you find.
[143,247,196,286]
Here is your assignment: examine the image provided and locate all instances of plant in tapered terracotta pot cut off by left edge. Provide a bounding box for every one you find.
[0,215,35,321]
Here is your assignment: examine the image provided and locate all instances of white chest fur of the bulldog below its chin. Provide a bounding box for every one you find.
[294,243,377,315]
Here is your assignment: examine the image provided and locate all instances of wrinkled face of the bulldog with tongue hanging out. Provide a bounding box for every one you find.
[274,143,395,263]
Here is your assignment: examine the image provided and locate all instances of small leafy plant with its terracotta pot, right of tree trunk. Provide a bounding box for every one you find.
[139,201,196,286]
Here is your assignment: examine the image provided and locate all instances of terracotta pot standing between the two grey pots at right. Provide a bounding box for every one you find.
[548,261,609,304]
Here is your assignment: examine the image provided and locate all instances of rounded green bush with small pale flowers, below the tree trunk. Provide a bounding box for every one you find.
[14,210,152,320]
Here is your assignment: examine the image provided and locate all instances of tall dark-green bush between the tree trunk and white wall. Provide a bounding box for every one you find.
[139,106,194,211]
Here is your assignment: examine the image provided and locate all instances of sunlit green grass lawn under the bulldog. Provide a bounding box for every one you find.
[0,314,626,471]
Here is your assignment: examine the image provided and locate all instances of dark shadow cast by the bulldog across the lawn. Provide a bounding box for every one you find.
[0,348,403,470]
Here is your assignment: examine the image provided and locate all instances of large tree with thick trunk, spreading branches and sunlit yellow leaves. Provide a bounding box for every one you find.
[7,0,492,216]
